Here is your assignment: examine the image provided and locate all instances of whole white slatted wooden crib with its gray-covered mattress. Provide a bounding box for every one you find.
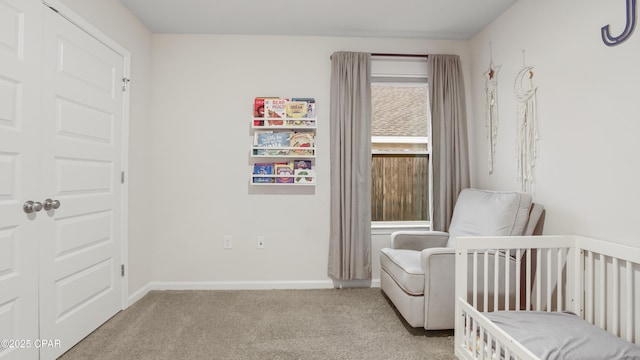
[455,236,640,359]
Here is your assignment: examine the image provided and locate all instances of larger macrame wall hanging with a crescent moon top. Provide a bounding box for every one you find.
[513,50,538,193]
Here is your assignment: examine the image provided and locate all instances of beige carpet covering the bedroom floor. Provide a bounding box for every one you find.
[60,288,455,360]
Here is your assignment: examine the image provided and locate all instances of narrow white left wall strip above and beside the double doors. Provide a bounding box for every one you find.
[61,0,153,294]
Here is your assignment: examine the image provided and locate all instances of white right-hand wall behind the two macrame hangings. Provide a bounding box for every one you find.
[470,0,640,245]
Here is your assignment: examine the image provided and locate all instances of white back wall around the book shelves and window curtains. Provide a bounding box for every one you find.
[149,34,469,288]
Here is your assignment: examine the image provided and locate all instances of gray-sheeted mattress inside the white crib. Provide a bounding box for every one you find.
[485,311,640,360]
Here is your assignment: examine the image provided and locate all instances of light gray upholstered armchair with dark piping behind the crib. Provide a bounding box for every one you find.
[380,189,544,330]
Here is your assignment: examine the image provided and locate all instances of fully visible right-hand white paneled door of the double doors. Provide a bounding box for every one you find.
[40,4,124,359]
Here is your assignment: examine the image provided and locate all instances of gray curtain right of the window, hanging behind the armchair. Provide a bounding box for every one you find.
[428,55,471,231]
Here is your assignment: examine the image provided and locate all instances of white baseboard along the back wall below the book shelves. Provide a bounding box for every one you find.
[129,279,380,306]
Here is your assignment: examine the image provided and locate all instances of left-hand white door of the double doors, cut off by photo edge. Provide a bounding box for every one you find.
[0,0,42,360]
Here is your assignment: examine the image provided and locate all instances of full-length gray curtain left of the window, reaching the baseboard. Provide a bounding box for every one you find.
[328,52,371,280]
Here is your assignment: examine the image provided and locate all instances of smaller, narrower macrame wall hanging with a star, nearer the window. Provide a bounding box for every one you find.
[484,44,500,174]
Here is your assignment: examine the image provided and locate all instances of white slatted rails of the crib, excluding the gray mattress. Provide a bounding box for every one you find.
[456,236,640,359]
